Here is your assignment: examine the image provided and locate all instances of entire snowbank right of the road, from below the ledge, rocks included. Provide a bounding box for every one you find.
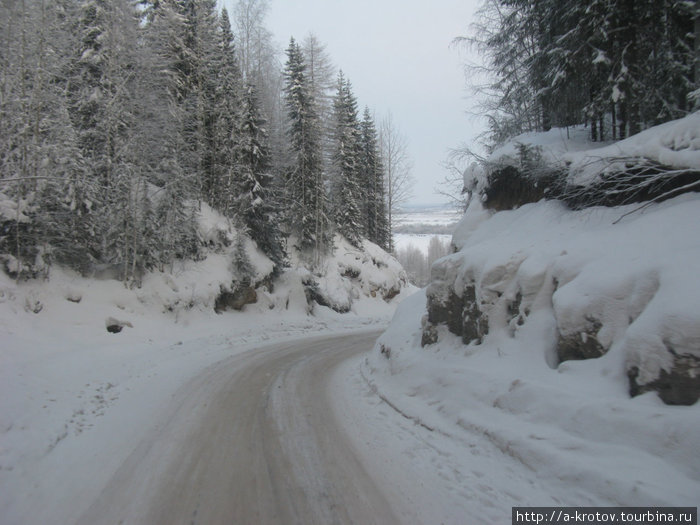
[365,194,700,510]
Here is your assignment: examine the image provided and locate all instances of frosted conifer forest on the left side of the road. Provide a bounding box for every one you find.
[0,0,391,284]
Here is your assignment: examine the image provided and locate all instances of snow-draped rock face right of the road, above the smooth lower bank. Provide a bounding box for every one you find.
[422,194,700,404]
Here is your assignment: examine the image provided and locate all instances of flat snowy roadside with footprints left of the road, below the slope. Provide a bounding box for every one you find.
[0,262,410,525]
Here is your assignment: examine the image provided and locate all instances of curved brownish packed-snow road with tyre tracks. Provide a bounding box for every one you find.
[79,333,398,525]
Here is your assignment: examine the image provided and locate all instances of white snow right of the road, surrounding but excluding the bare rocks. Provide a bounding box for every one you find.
[362,196,700,523]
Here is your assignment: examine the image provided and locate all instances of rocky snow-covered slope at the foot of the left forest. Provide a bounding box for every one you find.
[0,204,415,332]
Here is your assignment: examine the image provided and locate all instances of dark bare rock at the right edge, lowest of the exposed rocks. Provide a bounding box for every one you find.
[627,349,700,405]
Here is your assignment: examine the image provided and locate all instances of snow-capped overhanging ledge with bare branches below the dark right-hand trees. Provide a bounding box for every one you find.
[464,112,700,210]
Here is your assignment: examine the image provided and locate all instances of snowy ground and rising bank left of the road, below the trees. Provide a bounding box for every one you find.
[0,200,415,525]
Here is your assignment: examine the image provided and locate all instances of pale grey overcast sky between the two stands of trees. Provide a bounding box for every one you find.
[220,0,480,204]
